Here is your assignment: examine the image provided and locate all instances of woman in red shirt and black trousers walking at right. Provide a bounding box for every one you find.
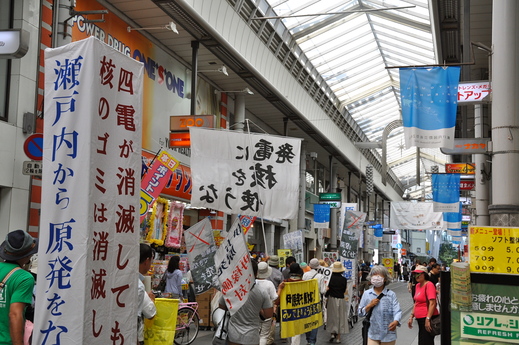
[407,266,439,345]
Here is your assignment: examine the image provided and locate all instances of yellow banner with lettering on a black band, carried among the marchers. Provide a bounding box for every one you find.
[280,279,323,338]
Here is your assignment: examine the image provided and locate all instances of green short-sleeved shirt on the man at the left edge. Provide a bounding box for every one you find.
[0,262,34,344]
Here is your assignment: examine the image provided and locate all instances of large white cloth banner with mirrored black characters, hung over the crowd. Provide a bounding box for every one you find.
[189,127,301,219]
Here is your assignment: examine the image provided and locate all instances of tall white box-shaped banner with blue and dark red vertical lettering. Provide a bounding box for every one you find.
[33,37,144,344]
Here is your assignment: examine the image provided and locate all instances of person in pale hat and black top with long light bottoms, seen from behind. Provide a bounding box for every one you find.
[326,261,349,344]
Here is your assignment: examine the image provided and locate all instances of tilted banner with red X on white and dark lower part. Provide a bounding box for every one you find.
[184,218,220,295]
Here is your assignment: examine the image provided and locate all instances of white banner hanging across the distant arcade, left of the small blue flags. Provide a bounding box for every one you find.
[389,201,443,230]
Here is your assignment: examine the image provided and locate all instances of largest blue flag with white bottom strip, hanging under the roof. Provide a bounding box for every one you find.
[400,66,460,148]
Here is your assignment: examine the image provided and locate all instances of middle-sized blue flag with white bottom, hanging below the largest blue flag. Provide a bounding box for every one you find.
[432,174,461,212]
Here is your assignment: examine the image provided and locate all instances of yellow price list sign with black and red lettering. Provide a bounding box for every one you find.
[469,226,519,274]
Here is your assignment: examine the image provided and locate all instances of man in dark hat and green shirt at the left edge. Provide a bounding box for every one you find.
[0,230,38,345]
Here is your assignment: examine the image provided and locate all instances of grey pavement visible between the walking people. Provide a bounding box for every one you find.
[192,281,441,345]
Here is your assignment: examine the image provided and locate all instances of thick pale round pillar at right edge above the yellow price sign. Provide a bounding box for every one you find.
[489,0,519,227]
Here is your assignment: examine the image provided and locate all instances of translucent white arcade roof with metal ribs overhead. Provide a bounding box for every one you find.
[267,0,447,198]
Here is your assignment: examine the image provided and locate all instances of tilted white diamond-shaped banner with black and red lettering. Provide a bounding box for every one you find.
[215,218,256,315]
